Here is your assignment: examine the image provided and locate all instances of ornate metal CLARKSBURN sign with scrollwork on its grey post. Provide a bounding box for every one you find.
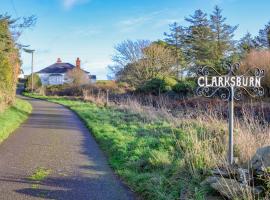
[196,63,264,165]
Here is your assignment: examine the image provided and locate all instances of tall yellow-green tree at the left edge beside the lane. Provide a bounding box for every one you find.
[0,15,35,111]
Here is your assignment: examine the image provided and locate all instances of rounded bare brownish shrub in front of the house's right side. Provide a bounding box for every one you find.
[67,67,90,86]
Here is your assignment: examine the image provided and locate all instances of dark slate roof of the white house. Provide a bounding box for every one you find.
[37,63,89,74]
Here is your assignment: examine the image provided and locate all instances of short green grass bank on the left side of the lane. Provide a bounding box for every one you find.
[0,99,32,143]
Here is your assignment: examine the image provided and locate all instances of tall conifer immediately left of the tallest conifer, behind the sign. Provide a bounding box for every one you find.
[185,10,214,67]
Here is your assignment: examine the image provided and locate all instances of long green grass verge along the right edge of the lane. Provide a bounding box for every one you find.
[23,94,219,200]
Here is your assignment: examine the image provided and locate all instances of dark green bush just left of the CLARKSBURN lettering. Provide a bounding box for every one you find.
[173,80,196,96]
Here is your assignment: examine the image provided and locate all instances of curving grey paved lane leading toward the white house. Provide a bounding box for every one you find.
[0,96,135,200]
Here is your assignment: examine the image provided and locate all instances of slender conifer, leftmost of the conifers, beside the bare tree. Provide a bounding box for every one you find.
[164,22,186,78]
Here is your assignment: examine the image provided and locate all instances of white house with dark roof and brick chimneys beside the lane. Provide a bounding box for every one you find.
[37,58,93,85]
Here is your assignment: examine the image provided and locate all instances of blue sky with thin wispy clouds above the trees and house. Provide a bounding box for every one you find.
[0,0,270,79]
